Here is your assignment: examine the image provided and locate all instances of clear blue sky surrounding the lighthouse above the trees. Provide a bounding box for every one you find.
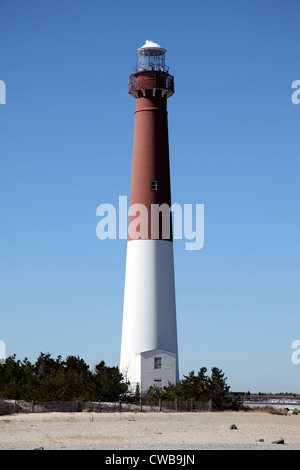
[0,0,300,393]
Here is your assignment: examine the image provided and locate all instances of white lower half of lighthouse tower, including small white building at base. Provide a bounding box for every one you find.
[120,240,178,391]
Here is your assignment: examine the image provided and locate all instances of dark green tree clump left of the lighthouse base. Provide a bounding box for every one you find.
[0,353,128,401]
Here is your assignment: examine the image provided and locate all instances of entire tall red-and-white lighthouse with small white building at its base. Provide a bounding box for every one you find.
[120,41,179,391]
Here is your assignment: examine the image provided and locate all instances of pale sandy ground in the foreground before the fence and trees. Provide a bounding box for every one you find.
[0,411,300,450]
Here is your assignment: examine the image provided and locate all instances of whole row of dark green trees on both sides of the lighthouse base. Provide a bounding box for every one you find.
[0,353,237,410]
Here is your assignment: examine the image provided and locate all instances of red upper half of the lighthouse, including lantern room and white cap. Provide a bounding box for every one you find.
[128,41,174,241]
